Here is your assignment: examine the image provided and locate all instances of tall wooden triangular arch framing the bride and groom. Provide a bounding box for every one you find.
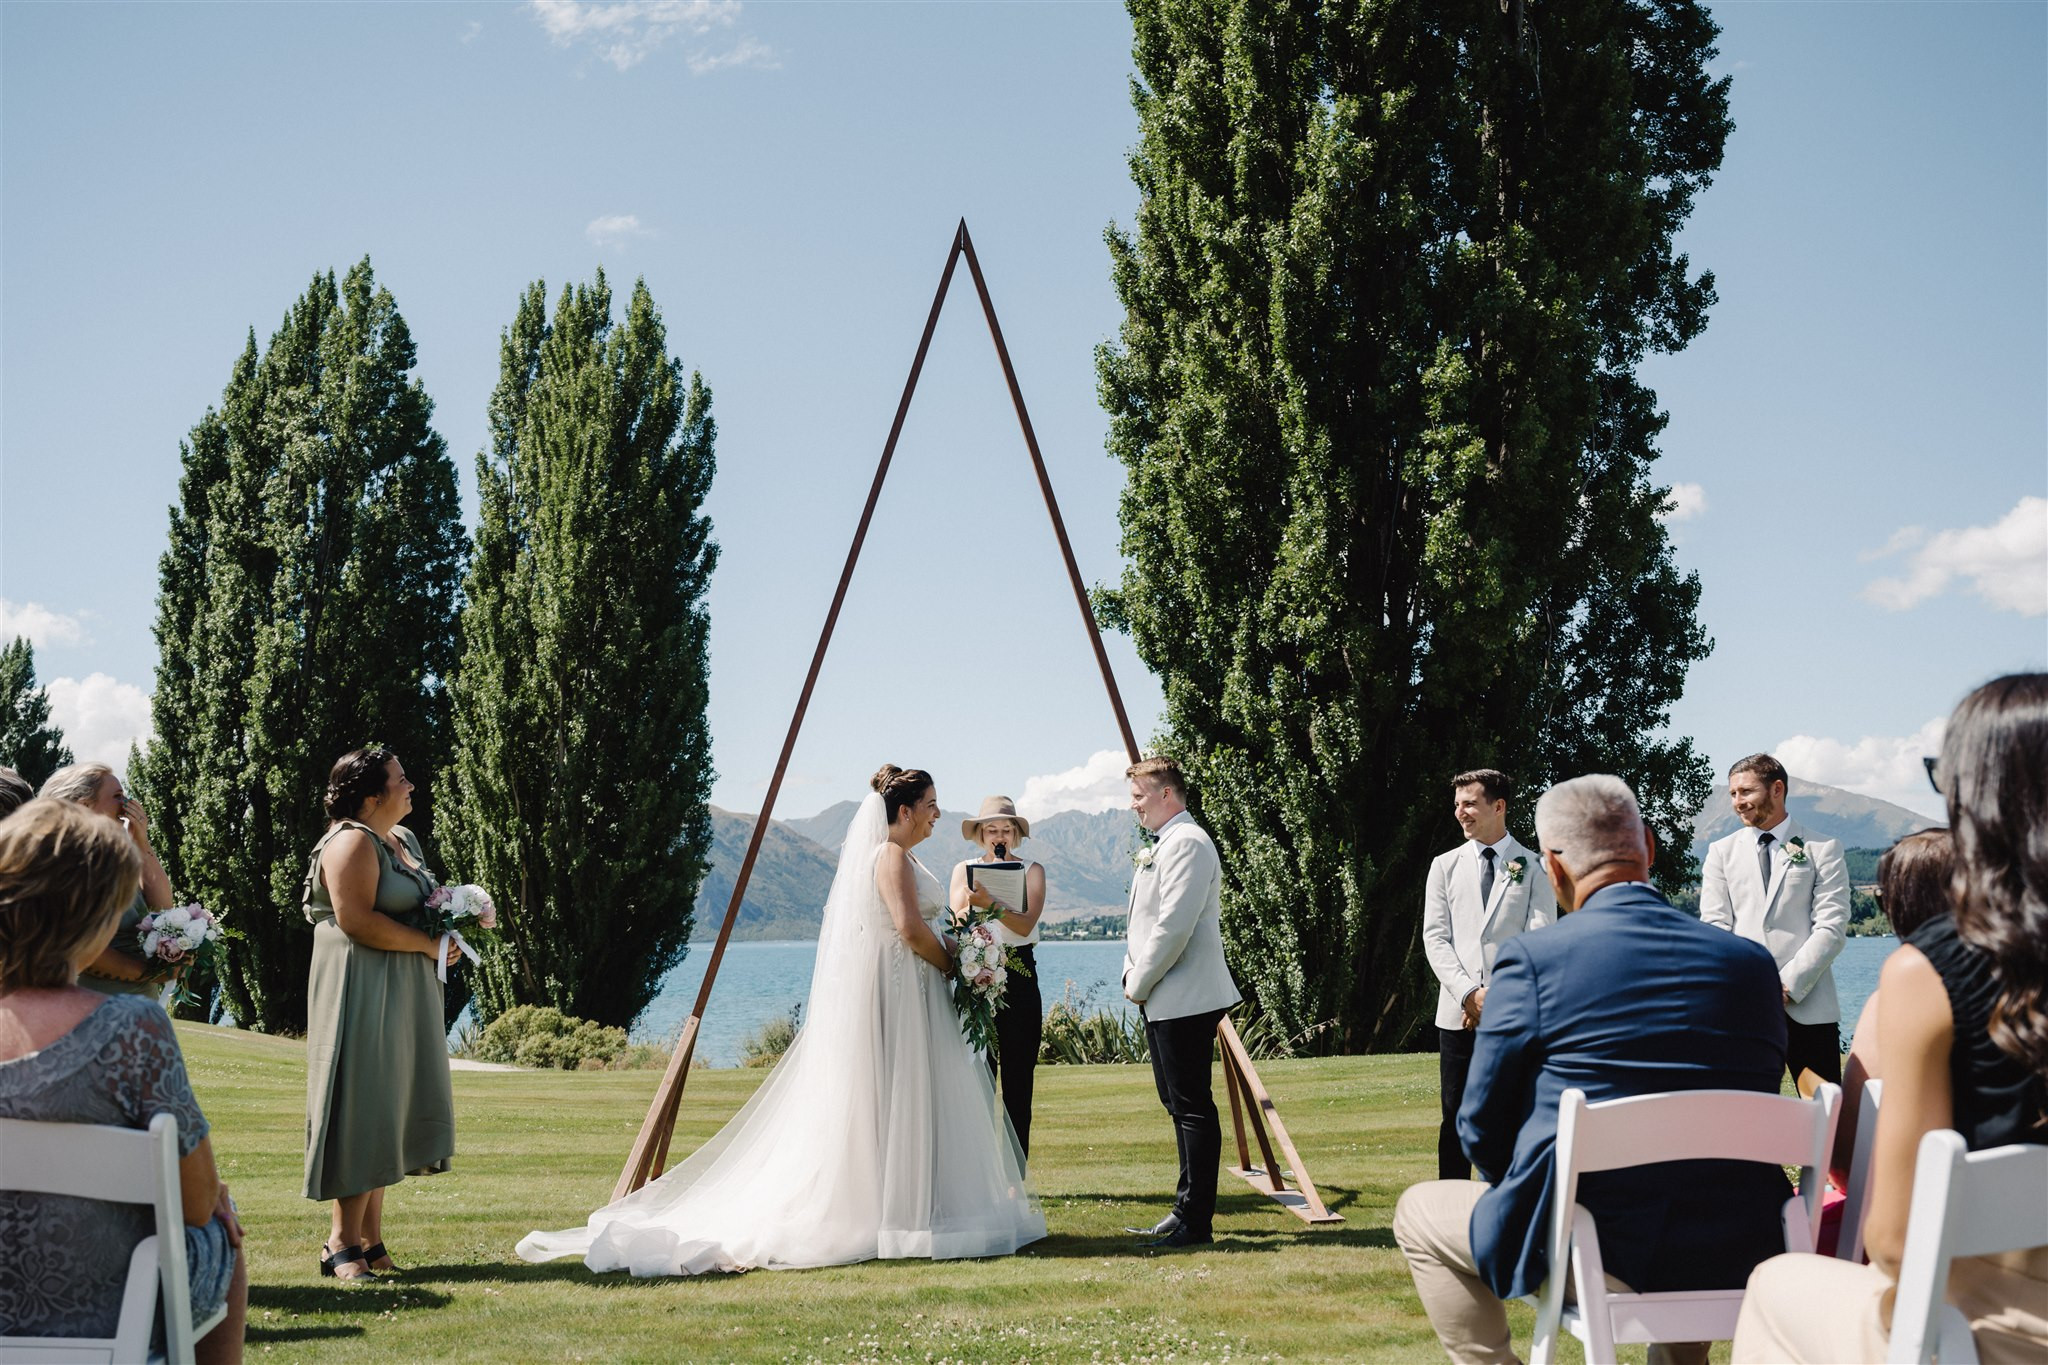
[612,219,1343,1224]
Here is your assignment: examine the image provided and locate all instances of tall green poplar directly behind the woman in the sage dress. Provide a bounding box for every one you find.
[131,260,467,1033]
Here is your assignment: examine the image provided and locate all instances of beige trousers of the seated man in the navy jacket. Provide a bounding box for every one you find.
[1395,1181,1708,1365]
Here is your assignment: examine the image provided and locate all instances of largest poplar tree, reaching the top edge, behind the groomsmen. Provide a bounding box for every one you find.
[1098,0,1731,1050]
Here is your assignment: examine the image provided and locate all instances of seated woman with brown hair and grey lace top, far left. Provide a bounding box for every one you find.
[0,800,248,1361]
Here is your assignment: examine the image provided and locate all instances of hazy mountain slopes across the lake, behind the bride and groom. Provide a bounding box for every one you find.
[708,800,1137,941]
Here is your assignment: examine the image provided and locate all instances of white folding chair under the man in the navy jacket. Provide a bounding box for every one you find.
[1530,1083,1841,1365]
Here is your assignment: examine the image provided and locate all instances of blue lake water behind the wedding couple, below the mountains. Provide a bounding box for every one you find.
[633,937,1898,1066]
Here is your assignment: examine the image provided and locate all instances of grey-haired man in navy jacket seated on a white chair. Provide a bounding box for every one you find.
[1395,774,1792,1365]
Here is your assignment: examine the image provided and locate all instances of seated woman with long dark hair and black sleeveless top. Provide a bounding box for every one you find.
[1733,673,2048,1365]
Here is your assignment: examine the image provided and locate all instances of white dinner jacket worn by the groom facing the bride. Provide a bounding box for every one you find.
[1124,810,1243,1019]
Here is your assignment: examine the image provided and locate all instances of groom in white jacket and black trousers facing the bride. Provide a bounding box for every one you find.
[1124,759,1241,1246]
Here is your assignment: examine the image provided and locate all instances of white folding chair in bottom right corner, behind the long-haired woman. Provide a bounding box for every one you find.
[1886,1128,2048,1365]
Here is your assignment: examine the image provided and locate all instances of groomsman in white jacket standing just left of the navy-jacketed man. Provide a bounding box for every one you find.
[1421,767,1556,1181]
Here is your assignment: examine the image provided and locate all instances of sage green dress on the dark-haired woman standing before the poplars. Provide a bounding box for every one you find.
[303,821,455,1199]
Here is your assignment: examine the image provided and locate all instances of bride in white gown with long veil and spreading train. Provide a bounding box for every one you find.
[518,765,1044,1275]
